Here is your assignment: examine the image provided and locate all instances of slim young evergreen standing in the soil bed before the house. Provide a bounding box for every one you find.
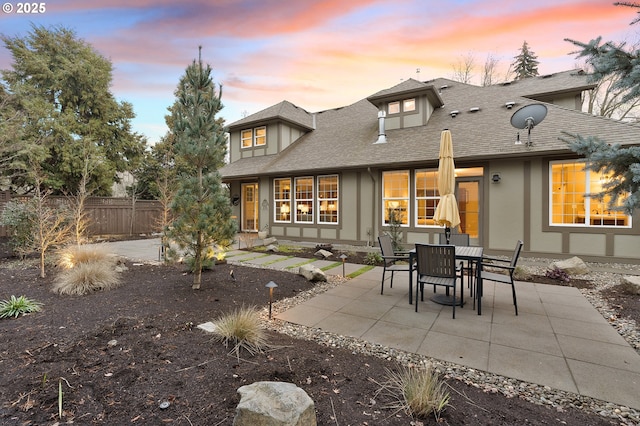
[168,49,236,289]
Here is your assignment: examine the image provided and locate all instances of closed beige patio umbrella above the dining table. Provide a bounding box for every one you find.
[433,129,460,244]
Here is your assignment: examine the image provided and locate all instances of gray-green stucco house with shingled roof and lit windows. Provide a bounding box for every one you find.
[221,70,640,262]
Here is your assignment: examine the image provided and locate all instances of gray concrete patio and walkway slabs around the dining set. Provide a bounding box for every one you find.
[105,240,640,409]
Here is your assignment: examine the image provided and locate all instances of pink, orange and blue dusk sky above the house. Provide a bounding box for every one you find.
[0,0,640,143]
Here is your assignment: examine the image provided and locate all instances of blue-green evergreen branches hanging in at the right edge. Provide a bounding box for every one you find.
[565,3,640,214]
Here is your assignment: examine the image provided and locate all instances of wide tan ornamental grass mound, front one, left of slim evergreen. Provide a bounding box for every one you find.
[52,261,120,296]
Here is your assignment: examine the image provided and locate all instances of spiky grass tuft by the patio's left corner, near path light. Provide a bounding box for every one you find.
[213,306,267,359]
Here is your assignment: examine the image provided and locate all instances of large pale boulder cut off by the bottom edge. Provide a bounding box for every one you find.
[233,382,317,426]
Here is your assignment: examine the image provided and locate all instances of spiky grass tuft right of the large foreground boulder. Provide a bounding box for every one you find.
[376,366,450,420]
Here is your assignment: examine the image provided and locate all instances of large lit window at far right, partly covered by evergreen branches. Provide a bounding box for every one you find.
[549,161,631,227]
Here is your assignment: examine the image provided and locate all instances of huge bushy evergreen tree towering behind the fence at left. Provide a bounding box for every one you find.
[1,25,146,195]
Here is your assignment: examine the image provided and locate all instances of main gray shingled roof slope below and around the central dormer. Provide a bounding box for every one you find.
[221,72,640,179]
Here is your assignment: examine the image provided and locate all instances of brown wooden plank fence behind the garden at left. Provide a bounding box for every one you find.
[0,191,162,237]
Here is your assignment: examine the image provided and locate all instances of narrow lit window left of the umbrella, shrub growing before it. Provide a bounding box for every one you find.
[382,170,409,225]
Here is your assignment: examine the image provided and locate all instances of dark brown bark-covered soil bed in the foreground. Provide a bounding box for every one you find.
[0,241,638,426]
